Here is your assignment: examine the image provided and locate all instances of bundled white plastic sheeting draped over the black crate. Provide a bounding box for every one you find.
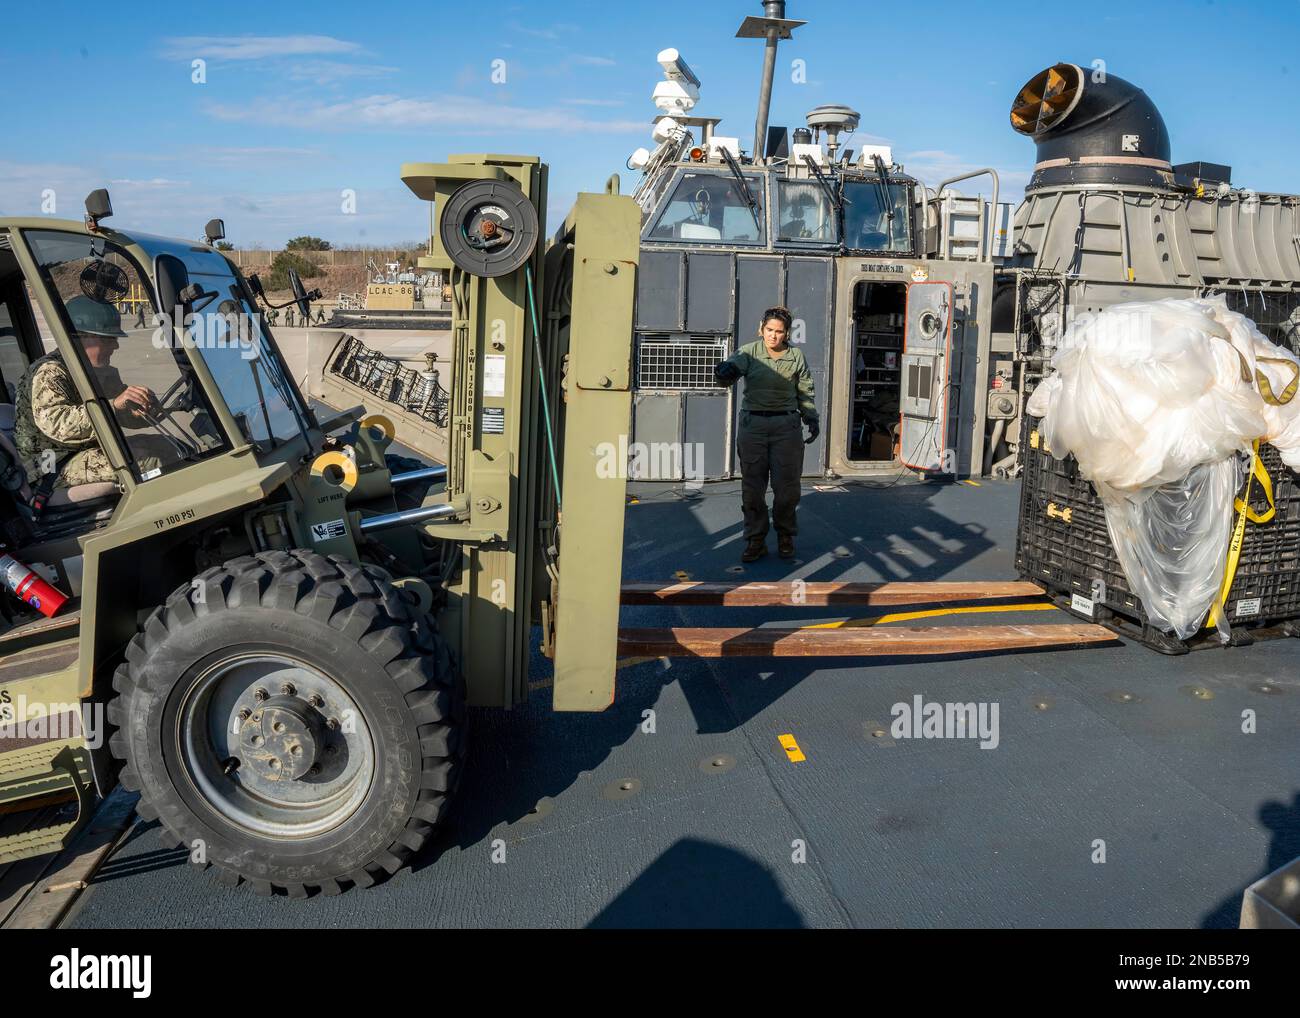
[1026,296,1300,638]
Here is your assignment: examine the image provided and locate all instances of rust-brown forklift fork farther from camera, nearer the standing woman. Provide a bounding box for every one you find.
[620,580,1043,607]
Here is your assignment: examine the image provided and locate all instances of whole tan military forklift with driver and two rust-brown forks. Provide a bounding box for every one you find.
[0,155,1110,897]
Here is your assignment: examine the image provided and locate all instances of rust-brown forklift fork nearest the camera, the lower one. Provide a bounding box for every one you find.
[619,623,1117,658]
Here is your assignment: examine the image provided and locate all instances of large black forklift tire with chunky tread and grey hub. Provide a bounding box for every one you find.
[108,550,465,897]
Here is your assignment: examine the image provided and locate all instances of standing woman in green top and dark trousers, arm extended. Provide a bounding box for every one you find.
[714,307,820,562]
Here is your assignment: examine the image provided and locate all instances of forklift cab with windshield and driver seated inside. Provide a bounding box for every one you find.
[0,196,319,610]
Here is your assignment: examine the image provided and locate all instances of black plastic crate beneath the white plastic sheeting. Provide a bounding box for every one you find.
[1015,428,1300,654]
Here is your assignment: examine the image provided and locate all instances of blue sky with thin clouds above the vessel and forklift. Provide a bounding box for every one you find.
[0,0,1300,247]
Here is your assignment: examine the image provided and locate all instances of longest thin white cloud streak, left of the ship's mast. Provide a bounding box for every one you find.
[207,95,646,134]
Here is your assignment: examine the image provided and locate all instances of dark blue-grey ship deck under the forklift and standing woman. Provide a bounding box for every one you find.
[58,481,1300,928]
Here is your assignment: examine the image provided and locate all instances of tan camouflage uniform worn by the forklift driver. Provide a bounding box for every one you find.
[13,354,159,488]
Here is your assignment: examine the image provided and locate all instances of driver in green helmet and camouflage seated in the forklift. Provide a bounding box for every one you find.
[14,296,161,488]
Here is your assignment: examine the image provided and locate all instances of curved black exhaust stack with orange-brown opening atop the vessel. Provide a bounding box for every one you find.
[1011,64,1174,191]
